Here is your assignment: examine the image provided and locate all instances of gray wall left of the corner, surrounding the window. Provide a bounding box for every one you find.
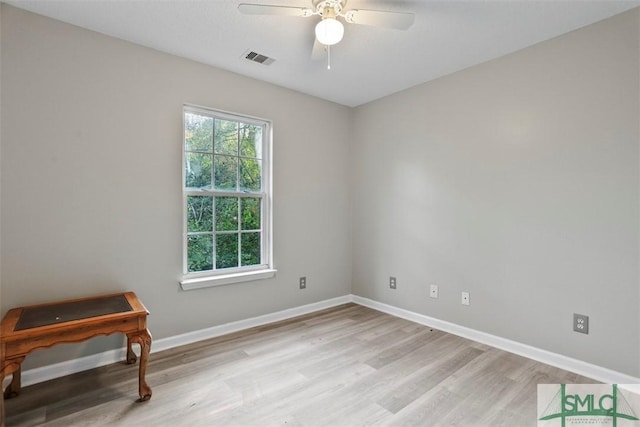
[1,4,351,368]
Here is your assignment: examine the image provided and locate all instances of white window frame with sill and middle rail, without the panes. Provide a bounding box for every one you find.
[180,104,277,290]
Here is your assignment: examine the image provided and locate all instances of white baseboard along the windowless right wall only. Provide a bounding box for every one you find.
[351,295,640,384]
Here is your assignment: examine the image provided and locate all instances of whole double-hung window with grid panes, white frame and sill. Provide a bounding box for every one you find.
[181,106,275,289]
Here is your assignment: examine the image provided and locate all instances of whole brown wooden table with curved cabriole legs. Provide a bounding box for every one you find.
[0,292,151,425]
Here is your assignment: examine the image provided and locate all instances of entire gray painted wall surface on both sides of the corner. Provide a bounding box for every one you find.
[0,5,640,376]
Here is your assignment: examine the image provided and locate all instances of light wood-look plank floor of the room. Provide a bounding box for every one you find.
[5,304,595,427]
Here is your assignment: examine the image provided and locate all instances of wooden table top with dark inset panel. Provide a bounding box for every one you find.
[0,292,149,341]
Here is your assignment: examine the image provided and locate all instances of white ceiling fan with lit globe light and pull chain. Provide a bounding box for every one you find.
[238,0,415,69]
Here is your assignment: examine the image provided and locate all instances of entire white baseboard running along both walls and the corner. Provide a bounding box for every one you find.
[12,295,640,386]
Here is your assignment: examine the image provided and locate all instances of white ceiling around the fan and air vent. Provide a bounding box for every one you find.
[4,0,640,106]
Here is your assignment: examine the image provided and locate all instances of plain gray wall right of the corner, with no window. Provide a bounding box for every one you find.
[351,9,640,376]
